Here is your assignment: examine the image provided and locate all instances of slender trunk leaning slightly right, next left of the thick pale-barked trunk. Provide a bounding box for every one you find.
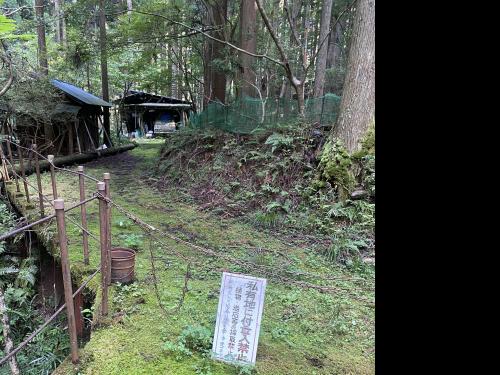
[314,0,333,98]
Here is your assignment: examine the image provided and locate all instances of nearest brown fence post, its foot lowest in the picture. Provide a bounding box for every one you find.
[54,199,78,363]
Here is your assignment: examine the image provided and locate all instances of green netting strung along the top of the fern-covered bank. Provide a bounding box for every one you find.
[189,94,340,134]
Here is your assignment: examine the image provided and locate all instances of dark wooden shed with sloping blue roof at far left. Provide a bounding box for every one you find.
[2,79,112,155]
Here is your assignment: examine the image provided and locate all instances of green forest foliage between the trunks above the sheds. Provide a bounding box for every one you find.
[0,0,353,108]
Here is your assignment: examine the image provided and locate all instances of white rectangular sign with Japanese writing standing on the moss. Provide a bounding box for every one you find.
[212,272,267,365]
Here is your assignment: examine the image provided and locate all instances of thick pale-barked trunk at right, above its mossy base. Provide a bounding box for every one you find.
[331,0,375,153]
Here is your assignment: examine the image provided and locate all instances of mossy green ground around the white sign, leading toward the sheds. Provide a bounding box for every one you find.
[9,142,374,375]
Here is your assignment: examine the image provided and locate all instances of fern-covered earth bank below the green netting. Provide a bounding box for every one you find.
[156,123,375,268]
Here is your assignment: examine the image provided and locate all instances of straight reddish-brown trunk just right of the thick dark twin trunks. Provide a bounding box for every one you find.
[240,0,258,97]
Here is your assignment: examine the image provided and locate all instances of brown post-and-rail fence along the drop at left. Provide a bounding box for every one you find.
[0,140,111,366]
